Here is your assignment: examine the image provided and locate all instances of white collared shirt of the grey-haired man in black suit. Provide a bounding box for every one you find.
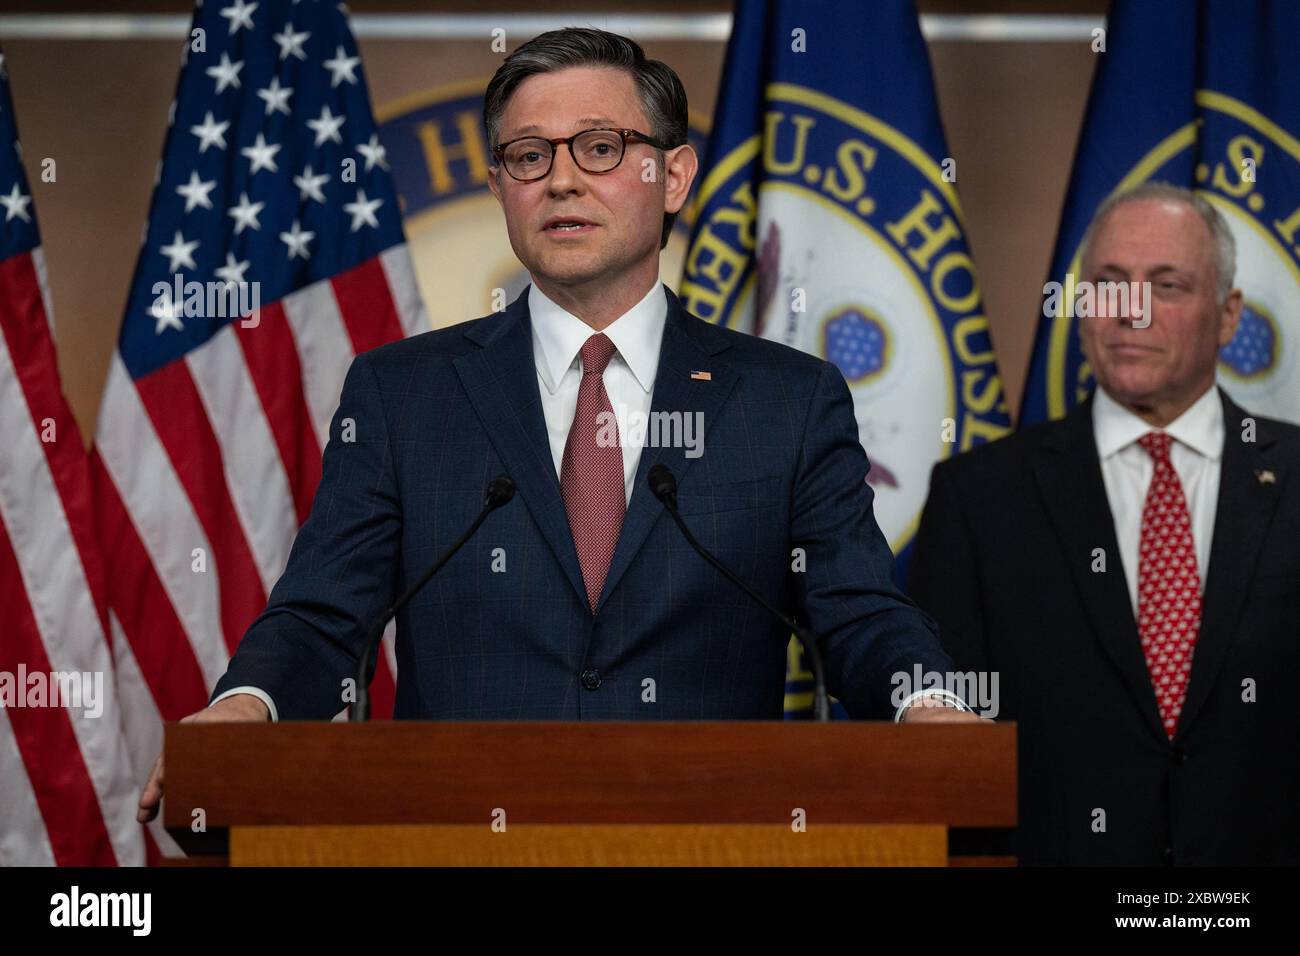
[1092,385,1225,617]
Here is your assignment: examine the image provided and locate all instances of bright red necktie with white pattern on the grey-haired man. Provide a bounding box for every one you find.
[1138,432,1201,740]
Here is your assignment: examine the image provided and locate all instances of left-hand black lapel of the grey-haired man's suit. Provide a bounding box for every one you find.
[1032,398,1165,737]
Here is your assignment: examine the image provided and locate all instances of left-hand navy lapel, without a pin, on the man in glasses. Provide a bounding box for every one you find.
[454,290,588,605]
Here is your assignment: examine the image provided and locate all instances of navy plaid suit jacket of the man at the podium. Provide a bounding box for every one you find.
[213,283,950,721]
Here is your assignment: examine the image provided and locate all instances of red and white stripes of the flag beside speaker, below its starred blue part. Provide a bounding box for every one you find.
[91,246,428,851]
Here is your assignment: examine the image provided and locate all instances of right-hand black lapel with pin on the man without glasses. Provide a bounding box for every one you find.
[1177,390,1286,739]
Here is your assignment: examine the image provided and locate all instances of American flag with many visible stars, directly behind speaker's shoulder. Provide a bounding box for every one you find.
[91,0,428,853]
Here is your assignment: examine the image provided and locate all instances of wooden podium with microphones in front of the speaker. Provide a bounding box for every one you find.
[164,721,1015,866]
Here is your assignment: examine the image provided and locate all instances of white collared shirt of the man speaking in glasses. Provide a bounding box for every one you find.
[528,277,668,502]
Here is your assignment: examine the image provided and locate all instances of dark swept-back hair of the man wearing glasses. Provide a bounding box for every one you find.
[484,27,688,248]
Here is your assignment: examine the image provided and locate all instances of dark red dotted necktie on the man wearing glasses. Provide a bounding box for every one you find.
[560,334,627,613]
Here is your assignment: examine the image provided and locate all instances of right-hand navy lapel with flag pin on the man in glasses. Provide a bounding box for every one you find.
[597,287,737,611]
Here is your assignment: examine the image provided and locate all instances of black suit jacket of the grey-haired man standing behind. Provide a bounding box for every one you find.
[910,395,1300,865]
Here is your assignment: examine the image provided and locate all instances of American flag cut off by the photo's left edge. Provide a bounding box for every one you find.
[0,55,144,866]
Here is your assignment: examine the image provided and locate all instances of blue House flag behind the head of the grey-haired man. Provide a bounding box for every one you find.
[1021,0,1300,424]
